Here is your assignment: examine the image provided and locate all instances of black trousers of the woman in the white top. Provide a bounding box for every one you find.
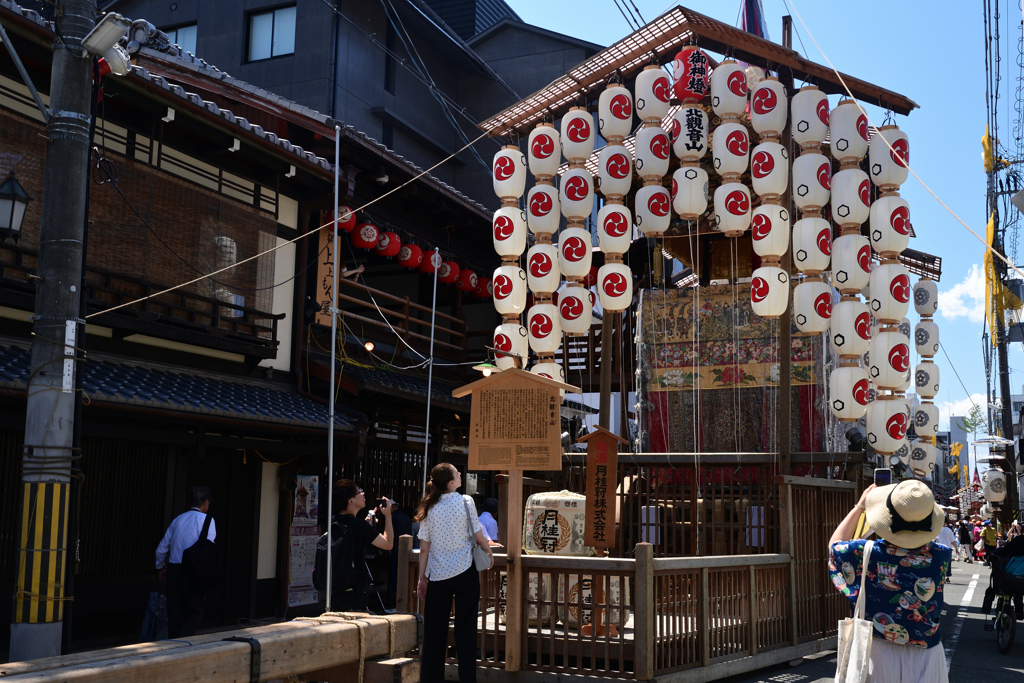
[420,564,480,683]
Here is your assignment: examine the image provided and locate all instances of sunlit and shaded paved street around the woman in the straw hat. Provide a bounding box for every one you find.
[727,562,1024,683]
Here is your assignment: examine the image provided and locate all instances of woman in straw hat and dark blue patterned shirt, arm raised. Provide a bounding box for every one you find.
[828,480,952,683]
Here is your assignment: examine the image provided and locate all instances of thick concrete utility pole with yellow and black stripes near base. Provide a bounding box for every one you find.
[10,0,96,661]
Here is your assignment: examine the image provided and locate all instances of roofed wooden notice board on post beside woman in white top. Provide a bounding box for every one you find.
[452,369,580,672]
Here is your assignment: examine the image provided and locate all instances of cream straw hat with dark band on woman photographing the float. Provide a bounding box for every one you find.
[864,479,946,548]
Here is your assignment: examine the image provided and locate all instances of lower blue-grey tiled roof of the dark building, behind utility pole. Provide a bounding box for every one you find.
[0,344,352,430]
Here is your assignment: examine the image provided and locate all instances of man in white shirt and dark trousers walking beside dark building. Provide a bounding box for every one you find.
[157,486,217,638]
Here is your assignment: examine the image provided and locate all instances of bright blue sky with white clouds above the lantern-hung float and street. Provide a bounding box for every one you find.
[508,0,1024,471]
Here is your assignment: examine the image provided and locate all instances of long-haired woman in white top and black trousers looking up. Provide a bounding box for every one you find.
[416,463,495,683]
